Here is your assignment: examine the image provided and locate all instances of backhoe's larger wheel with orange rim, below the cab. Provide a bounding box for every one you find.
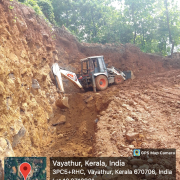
[95,75,108,91]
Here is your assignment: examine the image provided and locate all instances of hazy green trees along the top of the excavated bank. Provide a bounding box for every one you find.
[20,0,180,55]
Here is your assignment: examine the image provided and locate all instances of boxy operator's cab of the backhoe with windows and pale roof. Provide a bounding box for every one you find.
[81,56,108,77]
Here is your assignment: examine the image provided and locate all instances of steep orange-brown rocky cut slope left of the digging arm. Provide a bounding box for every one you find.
[0,1,58,170]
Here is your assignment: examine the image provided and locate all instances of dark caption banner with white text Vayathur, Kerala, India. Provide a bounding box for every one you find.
[50,149,176,180]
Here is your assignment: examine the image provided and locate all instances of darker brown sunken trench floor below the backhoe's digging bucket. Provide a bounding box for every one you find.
[44,92,111,157]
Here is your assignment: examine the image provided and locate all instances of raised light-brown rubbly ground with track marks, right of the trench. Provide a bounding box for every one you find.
[95,70,180,174]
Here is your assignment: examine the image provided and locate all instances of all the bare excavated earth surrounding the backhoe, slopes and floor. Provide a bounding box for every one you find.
[0,0,180,178]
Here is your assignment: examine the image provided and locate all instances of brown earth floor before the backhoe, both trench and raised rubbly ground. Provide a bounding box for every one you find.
[41,70,180,179]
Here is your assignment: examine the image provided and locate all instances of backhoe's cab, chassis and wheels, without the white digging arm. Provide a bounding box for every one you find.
[78,56,125,92]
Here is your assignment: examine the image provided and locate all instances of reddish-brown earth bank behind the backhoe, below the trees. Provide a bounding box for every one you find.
[54,28,180,76]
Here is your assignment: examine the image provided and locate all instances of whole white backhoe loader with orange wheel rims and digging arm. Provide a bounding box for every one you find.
[51,56,132,108]
